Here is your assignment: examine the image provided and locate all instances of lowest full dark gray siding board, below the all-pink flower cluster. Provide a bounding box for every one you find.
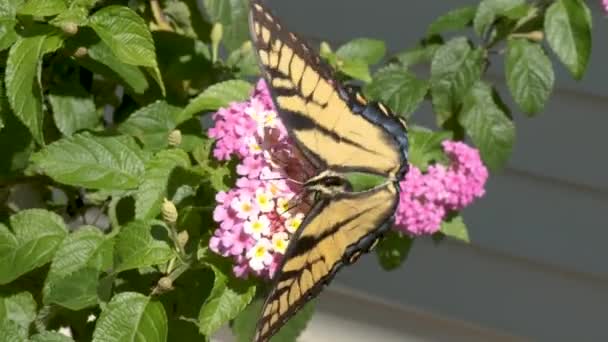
[337,240,608,341]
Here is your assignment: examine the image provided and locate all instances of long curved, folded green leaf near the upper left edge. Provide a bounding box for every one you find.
[5,35,62,144]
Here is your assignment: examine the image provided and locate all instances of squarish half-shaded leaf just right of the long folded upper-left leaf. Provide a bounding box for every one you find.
[48,82,99,136]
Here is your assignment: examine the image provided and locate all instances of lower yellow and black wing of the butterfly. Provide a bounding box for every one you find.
[254,182,398,342]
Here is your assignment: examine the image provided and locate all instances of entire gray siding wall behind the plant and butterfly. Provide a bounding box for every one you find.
[269,0,608,341]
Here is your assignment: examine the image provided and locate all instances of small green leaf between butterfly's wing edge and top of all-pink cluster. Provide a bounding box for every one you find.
[408,127,452,171]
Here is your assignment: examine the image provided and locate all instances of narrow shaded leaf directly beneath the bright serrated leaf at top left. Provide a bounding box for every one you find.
[77,41,149,94]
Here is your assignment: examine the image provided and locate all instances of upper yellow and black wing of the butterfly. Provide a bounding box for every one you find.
[249,1,407,177]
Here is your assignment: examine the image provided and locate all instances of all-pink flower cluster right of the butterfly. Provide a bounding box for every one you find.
[395,141,488,235]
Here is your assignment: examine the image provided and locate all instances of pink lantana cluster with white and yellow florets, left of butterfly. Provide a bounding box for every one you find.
[208,82,314,278]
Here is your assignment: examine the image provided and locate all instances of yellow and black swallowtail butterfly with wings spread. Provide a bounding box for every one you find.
[249,0,408,342]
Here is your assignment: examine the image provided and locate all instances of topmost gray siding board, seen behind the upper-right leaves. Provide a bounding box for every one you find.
[269,0,608,97]
